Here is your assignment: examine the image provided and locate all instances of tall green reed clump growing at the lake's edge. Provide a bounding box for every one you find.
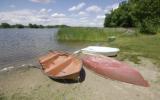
[57,27,126,41]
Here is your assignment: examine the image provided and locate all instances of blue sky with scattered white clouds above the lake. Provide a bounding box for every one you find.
[0,0,123,27]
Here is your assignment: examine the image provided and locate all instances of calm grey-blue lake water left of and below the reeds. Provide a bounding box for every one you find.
[0,29,102,69]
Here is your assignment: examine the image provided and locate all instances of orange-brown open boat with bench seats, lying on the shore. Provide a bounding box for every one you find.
[39,51,82,79]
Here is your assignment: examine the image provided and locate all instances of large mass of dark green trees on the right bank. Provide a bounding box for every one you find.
[104,0,160,34]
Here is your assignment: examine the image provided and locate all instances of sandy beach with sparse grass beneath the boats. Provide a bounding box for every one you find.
[0,57,160,100]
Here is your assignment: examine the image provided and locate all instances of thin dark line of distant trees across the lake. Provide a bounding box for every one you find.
[0,23,69,28]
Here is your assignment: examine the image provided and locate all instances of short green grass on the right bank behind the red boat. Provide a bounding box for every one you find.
[111,34,160,65]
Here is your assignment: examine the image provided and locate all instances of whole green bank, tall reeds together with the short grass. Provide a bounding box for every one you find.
[58,28,160,65]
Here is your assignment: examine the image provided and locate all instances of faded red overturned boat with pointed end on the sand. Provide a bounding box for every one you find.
[83,55,149,87]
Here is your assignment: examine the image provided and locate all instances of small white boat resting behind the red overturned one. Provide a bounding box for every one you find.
[81,46,120,56]
